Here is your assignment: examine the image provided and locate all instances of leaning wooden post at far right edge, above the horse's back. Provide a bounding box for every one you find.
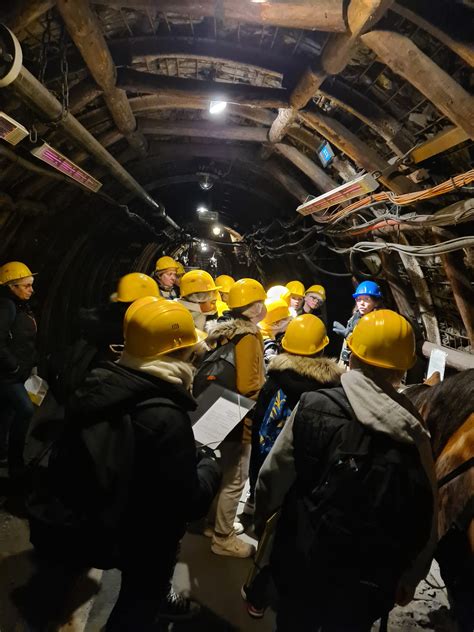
[433,228,474,348]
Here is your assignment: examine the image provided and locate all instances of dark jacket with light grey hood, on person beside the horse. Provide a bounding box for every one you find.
[256,370,437,604]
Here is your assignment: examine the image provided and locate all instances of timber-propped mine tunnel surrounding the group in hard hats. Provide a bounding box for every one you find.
[0,0,474,632]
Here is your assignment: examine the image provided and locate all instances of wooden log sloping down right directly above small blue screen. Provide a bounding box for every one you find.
[299,112,416,193]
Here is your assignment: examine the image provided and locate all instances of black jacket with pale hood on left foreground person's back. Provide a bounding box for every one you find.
[45,356,220,567]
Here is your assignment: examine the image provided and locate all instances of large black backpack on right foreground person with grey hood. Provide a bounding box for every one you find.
[295,388,433,597]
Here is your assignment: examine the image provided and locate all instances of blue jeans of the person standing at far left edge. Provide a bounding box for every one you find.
[0,383,34,476]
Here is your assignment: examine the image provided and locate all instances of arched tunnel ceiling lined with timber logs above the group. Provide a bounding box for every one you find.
[0,0,474,356]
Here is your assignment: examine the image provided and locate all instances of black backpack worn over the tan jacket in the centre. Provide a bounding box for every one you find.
[193,334,247,397]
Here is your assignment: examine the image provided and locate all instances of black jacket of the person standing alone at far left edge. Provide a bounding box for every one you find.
[0,287,37,383]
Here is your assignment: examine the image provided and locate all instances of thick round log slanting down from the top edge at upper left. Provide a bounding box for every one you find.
[57,0,147,157]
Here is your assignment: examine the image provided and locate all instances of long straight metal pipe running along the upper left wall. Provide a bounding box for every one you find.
[12,66,179,229]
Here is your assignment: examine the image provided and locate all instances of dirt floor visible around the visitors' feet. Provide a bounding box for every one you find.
[0,488,462,632]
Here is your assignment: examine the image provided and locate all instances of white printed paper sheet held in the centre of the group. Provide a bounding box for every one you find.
[193,397,253,450]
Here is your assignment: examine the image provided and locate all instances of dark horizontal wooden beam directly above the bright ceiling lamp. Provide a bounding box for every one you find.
[117,68,288,108]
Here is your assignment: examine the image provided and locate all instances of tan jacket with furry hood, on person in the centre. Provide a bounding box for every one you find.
[206,312,265,399]
